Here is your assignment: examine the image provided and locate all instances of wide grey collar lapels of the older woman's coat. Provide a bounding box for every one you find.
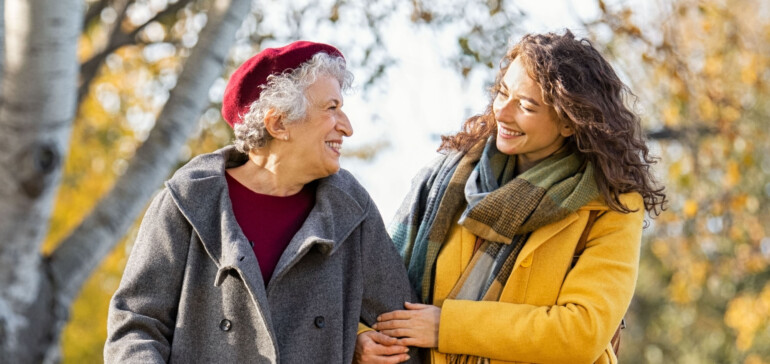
[166,146,369,285]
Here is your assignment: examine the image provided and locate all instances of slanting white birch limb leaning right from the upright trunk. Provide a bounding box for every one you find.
[50,0,251,303]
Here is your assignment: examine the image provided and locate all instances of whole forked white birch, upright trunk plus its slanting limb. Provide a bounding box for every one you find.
[0,0,250,363]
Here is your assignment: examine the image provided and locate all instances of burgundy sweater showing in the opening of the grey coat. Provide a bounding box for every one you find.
[225,173,316,286]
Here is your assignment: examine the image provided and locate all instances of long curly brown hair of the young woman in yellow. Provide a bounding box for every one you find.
[439,30,666,216]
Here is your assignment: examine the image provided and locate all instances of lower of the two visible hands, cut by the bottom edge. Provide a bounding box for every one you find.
[353,331,409,364]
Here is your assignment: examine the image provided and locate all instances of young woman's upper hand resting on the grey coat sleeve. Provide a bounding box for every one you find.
[372,302,441,348]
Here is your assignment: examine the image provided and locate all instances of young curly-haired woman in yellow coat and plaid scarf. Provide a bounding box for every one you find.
[356,31,665,363]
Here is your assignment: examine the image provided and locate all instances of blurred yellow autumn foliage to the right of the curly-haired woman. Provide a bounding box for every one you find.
[588,0,770,363]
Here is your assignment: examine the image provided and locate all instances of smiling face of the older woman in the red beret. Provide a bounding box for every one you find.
[287,75,353,178]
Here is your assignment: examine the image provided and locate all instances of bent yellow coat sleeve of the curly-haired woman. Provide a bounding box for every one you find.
[438,194,644,363]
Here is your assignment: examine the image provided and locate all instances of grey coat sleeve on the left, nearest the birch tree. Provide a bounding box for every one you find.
[104,190,192,363]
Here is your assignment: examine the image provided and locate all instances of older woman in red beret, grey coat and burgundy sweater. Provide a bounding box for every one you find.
[104,42,414,363]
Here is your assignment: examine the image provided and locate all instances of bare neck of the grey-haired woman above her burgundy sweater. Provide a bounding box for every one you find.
[227,147,312,196]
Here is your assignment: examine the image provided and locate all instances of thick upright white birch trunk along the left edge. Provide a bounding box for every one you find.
[0,0,83,363]
